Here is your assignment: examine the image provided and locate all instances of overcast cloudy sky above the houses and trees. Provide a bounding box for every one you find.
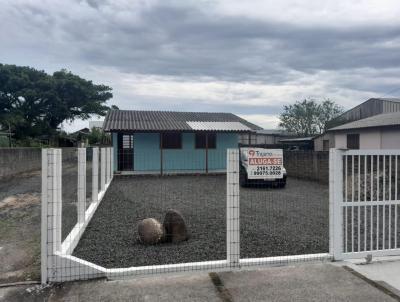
[0,0,400,130]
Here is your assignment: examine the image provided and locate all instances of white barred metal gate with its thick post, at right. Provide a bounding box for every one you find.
[330,149,400,260]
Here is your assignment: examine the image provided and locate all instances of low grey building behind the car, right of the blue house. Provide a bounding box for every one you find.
[239,129,296,147]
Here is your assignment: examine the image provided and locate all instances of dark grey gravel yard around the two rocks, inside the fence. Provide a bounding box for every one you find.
[74,175,329,268]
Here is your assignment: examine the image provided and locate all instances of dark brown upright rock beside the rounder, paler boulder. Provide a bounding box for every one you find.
[164,210,189,243]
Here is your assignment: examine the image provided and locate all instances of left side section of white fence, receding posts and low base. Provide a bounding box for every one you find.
[41,148,113,283]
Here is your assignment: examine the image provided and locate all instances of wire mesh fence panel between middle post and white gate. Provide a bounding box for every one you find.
[240,149,329,265]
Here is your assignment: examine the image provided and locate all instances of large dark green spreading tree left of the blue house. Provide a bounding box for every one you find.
[0,64,112,139]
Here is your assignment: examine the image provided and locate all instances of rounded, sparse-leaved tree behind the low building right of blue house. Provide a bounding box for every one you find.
[279,99,343,136]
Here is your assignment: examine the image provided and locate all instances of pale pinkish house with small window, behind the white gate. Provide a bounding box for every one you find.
[328,112,400,149]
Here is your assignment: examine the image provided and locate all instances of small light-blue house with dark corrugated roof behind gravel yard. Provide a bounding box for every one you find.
[103,110,261,173]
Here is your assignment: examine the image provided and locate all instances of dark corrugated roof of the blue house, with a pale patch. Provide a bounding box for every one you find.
[103,110,261,132]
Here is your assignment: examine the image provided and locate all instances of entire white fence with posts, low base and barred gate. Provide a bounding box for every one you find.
[42,148,400,282]
